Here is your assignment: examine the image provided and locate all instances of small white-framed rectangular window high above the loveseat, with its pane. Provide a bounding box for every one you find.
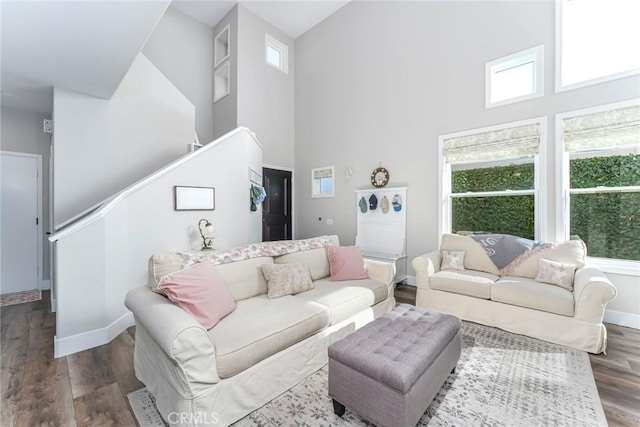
[485,45,544,108]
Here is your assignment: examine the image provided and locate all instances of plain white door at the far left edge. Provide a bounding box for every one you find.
[0,151,42,294]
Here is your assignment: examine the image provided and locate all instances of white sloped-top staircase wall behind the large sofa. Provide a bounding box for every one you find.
[54,129,262,357]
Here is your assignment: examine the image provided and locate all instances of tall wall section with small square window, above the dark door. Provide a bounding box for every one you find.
[238,5,295,168]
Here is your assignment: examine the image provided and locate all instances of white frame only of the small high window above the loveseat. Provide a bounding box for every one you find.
[484,45,544,108]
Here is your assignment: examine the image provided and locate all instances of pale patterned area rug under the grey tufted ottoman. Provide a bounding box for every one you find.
[129,322,607,427]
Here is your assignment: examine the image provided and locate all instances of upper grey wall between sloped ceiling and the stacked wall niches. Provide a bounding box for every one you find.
[142,7,214,144]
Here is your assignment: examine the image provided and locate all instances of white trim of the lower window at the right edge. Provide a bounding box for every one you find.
[555,99,640,277]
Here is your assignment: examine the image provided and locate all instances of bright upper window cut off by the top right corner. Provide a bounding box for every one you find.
[556,0,640,92]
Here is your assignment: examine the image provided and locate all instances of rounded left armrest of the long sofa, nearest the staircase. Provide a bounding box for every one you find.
[125,286,220,390]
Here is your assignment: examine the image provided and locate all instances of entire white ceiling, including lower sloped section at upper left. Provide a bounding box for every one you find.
[0,0,349,114]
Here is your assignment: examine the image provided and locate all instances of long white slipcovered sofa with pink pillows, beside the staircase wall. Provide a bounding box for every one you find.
[126,236,395,425]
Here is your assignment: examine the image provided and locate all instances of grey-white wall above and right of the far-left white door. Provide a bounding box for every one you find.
[0,107,51,280]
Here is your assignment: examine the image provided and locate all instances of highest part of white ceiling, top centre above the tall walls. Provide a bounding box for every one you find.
[171,0,350,39]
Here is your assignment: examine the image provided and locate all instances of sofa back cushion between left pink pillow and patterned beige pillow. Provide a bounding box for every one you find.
[216,257,273,301]
